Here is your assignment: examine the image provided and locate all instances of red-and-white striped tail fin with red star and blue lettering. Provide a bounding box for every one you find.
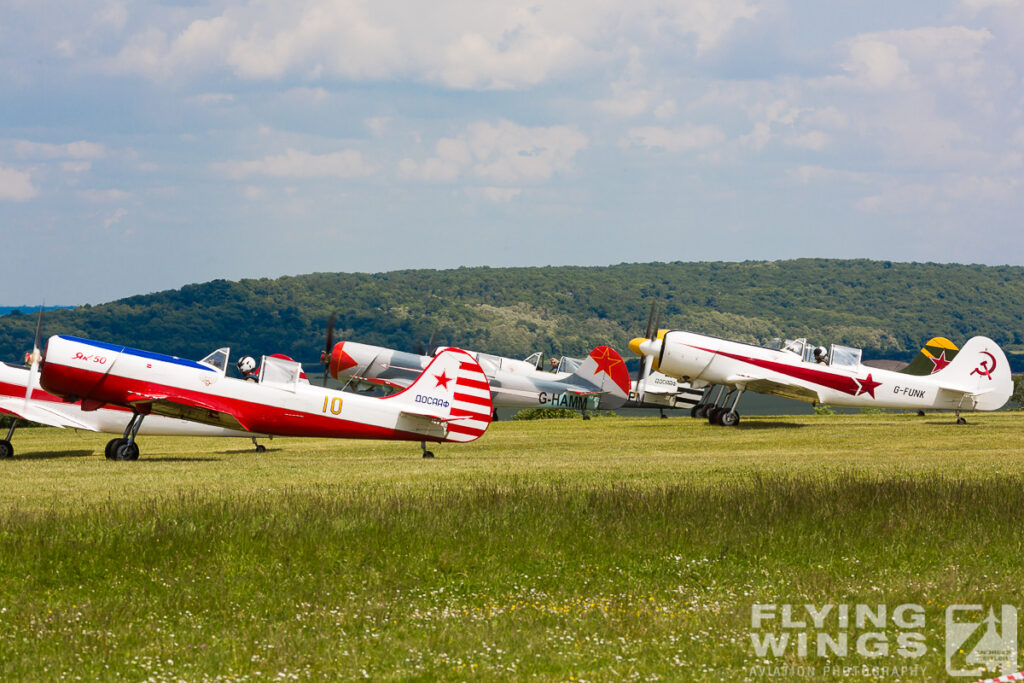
[381,347,494,441]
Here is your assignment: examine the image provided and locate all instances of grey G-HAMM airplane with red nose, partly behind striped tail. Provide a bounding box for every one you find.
[324,341,630,414]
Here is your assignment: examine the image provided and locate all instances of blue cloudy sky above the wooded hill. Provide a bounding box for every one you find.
[0,0,1024,305]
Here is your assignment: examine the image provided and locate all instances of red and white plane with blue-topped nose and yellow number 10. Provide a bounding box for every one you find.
[39,335,492,460]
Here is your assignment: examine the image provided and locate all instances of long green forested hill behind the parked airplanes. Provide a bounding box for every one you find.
[0,259,1024,370]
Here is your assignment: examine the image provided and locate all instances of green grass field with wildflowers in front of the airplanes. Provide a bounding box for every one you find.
[0,413,1024,681]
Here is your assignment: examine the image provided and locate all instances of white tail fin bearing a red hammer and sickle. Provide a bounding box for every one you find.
[934,337,1014,411]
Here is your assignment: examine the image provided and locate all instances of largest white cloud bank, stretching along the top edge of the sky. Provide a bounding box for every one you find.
[99,0,759,90]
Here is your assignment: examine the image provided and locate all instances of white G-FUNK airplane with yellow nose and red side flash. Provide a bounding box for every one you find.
[630,330,1013,426]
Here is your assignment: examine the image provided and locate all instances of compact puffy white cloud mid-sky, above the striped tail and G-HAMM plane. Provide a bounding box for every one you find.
[398,121,589,183]
